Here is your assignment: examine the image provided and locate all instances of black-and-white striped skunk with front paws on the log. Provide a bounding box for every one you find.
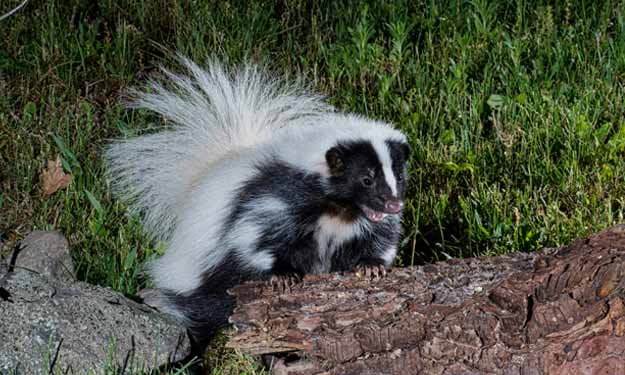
[105,58,410,352]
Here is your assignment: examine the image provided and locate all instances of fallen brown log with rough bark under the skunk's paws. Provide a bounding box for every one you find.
[229,226,625,375]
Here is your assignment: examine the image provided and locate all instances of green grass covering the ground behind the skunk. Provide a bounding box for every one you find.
[0,0,625,373]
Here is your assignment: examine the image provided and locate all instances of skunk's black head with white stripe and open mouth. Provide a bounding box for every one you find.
[326,140,410,222]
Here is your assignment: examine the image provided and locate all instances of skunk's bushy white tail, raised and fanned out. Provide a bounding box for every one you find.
[105,57,330,240]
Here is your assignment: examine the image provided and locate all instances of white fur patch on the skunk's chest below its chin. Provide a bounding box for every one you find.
[313,215,369,273]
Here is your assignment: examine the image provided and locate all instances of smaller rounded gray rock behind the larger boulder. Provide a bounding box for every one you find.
[15,230,74,281]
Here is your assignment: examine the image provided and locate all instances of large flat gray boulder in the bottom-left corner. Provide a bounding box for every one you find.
[0,235,190,375]
